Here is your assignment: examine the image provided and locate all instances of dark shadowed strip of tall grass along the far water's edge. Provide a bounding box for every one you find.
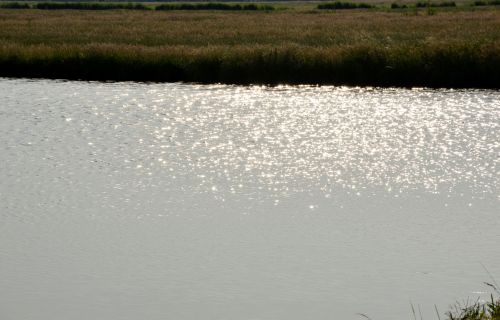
[0,44,500,88]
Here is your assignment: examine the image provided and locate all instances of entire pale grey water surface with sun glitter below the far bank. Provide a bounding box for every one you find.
[0,79,500,320]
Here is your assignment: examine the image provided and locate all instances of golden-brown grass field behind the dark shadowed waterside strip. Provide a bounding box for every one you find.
[0,10,500,47]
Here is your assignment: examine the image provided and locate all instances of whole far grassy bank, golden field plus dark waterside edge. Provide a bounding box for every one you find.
[0,10,500,88]
